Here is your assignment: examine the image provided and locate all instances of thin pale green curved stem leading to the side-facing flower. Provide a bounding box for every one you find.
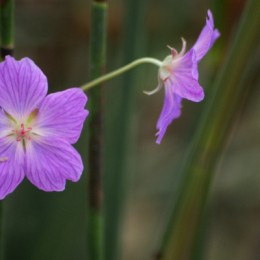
[81,57,162,91]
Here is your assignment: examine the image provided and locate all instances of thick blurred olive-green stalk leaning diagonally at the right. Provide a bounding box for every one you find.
[157,0,260,260]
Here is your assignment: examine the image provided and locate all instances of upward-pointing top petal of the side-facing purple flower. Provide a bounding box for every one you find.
[192,10,220,61]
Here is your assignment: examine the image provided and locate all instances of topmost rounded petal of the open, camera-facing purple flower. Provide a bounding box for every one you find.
[0,56,48,118]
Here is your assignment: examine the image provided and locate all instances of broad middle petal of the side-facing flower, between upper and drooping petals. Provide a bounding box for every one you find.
[171,49,204,102]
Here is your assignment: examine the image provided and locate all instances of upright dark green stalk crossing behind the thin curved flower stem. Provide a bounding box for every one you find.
[87,0,108,260]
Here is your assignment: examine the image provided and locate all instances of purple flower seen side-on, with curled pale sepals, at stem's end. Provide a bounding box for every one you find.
[146,11,220,144]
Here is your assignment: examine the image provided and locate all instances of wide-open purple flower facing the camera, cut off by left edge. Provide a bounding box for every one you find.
[0,56,88,199]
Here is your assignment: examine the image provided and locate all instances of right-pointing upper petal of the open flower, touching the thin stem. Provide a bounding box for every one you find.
[35,88,88,143]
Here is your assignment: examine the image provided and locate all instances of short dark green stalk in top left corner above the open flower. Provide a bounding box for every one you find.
[0,0,14,59]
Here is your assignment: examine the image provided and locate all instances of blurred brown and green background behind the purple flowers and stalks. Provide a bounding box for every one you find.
[4,0,260,260]
